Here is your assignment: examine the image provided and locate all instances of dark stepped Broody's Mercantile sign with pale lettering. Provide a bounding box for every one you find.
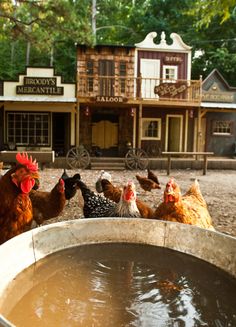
[16,77,64,95]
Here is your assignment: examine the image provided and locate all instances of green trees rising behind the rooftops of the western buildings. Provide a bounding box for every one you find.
[0,0,236,86]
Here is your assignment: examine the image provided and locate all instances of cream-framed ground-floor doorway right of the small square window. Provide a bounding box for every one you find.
[166,115,183,152]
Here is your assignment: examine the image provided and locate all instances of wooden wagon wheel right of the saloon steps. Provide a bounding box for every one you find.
[125,148,149,170]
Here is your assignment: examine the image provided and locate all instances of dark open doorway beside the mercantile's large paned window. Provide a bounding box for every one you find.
[52,113,70,157]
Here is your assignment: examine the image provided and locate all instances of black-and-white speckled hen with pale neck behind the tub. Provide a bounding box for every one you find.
[77,180,140,218]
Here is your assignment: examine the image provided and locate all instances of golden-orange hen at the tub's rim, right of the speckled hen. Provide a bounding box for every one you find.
[153,178,214,230]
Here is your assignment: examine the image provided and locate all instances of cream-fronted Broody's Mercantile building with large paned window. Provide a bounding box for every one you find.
[0,67,76,155]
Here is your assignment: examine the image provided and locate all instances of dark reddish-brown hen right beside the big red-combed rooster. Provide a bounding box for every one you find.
[30,178,66,225]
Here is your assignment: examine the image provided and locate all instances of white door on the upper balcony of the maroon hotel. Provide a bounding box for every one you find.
[140,59,160,99]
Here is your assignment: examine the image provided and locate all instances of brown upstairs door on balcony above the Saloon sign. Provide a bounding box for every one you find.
[98,60,115,96]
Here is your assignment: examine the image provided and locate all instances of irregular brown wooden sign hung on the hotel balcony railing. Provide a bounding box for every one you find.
[154,82,188,98]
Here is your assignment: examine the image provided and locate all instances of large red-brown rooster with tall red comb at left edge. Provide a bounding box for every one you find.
[0,153,39,244]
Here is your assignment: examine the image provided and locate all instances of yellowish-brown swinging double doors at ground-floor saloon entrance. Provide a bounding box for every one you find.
[92,120,118,149]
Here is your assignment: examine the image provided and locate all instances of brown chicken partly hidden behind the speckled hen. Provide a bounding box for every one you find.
[101,179,153,218]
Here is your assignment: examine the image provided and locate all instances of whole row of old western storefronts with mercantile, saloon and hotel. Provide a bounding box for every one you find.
[0,32,236,161]
